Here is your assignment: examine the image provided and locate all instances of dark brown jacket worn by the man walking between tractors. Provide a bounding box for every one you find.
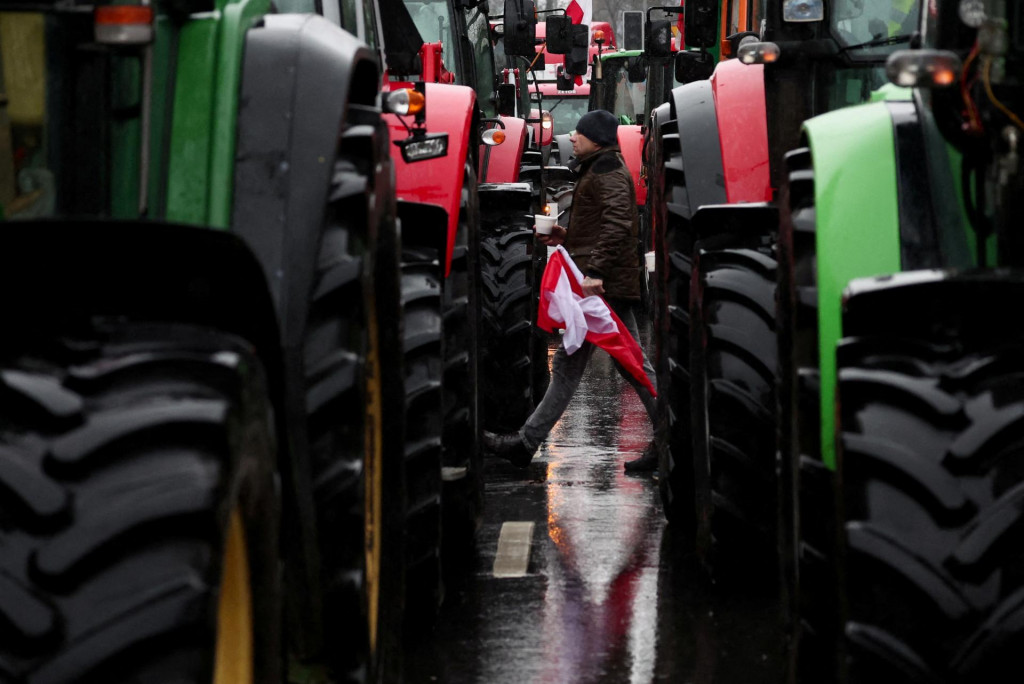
[565,145,640,300]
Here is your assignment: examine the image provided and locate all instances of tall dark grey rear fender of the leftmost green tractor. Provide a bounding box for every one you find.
[225,14,388,649]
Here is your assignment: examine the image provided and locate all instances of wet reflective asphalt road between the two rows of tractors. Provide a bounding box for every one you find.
[406,325,782,684]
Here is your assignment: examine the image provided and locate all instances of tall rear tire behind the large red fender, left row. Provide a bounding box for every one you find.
[441,161,483,573]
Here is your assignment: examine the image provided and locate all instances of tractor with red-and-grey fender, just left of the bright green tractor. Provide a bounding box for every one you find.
[648,0,919,597]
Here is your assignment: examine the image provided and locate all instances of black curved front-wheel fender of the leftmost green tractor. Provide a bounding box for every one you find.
[0,220,288,397]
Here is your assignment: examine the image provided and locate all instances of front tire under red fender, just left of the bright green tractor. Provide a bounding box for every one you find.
[690,242,777,583]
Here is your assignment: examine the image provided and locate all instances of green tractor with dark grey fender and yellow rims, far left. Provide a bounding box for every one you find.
[0,0,428,683]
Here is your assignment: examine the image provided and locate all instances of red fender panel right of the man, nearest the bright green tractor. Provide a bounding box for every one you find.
[711,59,773,204]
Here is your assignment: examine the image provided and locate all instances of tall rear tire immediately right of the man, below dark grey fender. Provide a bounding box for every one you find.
[648,108,694,536]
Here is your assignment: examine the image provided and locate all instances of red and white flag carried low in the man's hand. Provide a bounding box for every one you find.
[537,245,657,396]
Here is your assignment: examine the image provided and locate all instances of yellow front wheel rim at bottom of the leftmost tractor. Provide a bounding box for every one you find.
[213,509,253,684]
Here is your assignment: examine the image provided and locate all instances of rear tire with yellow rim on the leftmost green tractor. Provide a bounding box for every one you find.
[302,152,406,682]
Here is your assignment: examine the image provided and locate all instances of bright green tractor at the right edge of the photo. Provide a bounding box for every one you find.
[778,0,1024,683]
